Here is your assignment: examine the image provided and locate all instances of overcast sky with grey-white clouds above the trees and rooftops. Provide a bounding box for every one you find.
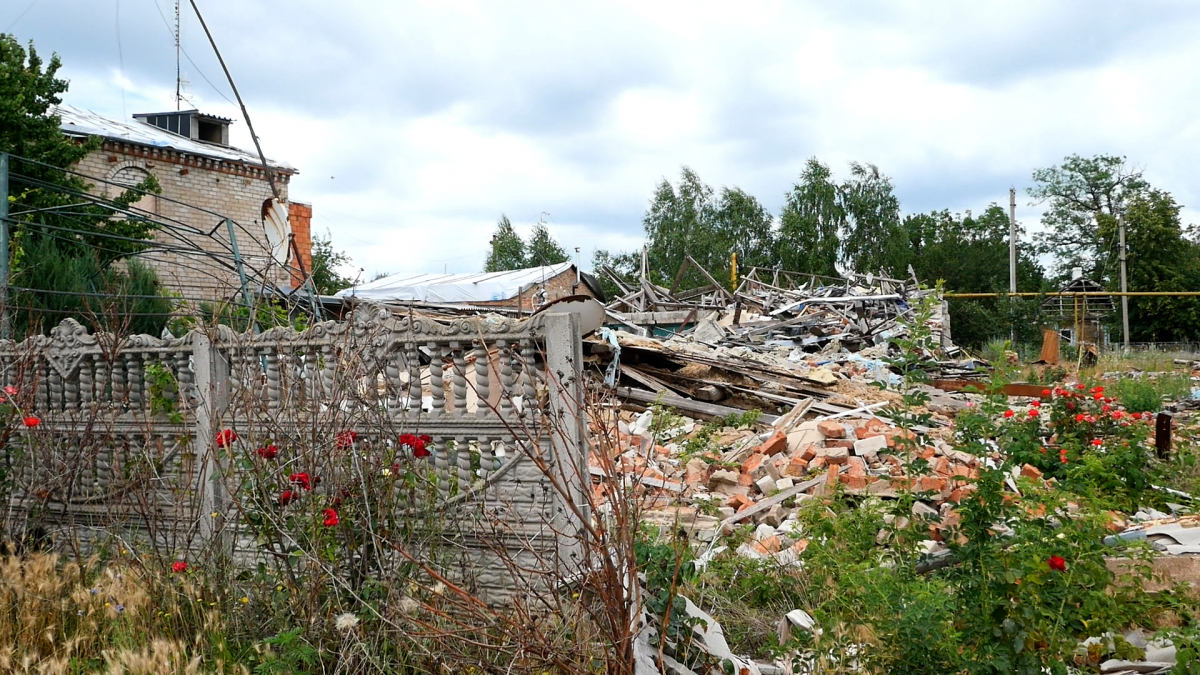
[9,0,1200,279]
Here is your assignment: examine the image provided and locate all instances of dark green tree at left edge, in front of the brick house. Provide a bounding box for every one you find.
[0,35,168,333]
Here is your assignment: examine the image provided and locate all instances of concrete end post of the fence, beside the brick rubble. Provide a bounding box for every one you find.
[544,313,590,566]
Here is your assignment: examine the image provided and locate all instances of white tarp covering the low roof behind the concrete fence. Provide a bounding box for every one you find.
[337,263,575,303]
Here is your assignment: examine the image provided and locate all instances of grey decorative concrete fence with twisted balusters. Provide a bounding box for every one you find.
[0,304,588,598]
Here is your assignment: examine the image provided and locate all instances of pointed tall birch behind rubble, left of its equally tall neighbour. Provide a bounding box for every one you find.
[778,157,846,276]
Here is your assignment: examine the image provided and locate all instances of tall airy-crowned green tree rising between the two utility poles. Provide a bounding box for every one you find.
[1028,155,1150,282]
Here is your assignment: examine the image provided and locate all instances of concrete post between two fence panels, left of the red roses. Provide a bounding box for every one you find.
[192,330,229,549]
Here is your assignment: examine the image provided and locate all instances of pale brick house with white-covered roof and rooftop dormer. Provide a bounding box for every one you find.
[58,106,312,299]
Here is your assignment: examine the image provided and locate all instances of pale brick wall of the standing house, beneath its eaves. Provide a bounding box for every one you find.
[76,142,297,299]
